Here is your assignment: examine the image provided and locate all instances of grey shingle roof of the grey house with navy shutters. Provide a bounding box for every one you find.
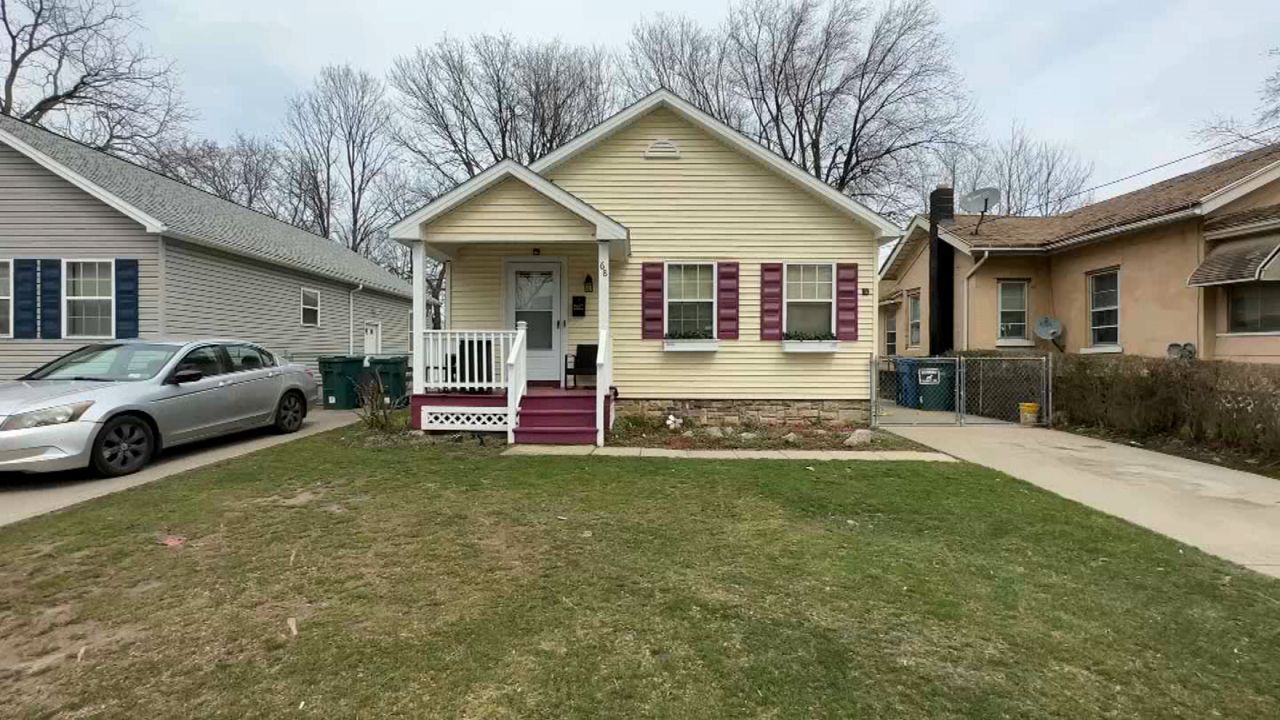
[0,115,412,297]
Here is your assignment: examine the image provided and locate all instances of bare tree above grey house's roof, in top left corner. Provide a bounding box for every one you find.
[0,0,189,158]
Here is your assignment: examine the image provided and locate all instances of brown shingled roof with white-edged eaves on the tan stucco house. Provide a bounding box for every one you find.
[931,143,1280,250]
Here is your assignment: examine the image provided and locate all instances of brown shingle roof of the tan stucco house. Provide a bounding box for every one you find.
[951,143,1280,249]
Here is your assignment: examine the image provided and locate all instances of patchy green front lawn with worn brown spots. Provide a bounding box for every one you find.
[0,429,1280,719]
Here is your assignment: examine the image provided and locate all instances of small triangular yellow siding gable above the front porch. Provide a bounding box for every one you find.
[426,178,595,243]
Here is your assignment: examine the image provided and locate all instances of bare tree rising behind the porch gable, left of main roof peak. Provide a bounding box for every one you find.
[390,35,616,191]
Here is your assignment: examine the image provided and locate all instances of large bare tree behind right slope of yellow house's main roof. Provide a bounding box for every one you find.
[627,0,973,214]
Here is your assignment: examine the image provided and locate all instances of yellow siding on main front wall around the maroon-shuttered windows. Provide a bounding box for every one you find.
[545,109,876,400]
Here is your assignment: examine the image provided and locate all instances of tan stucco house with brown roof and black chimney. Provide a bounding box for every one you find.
[878,145,1280,363]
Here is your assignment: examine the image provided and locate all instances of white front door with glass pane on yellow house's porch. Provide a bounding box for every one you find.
[507,263,563,382]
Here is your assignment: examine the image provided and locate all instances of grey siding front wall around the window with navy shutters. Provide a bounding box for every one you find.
[0,143,160,379]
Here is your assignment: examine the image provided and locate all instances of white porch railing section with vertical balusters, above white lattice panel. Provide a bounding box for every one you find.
[422,329,524,392]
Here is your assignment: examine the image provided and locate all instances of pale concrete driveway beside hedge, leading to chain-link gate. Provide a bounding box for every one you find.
[886,425,1280,578]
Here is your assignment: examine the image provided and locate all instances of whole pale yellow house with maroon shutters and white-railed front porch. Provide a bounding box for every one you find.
[392,91,900,445]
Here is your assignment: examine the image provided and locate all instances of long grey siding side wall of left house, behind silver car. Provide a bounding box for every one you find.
[165,238,410,365]
